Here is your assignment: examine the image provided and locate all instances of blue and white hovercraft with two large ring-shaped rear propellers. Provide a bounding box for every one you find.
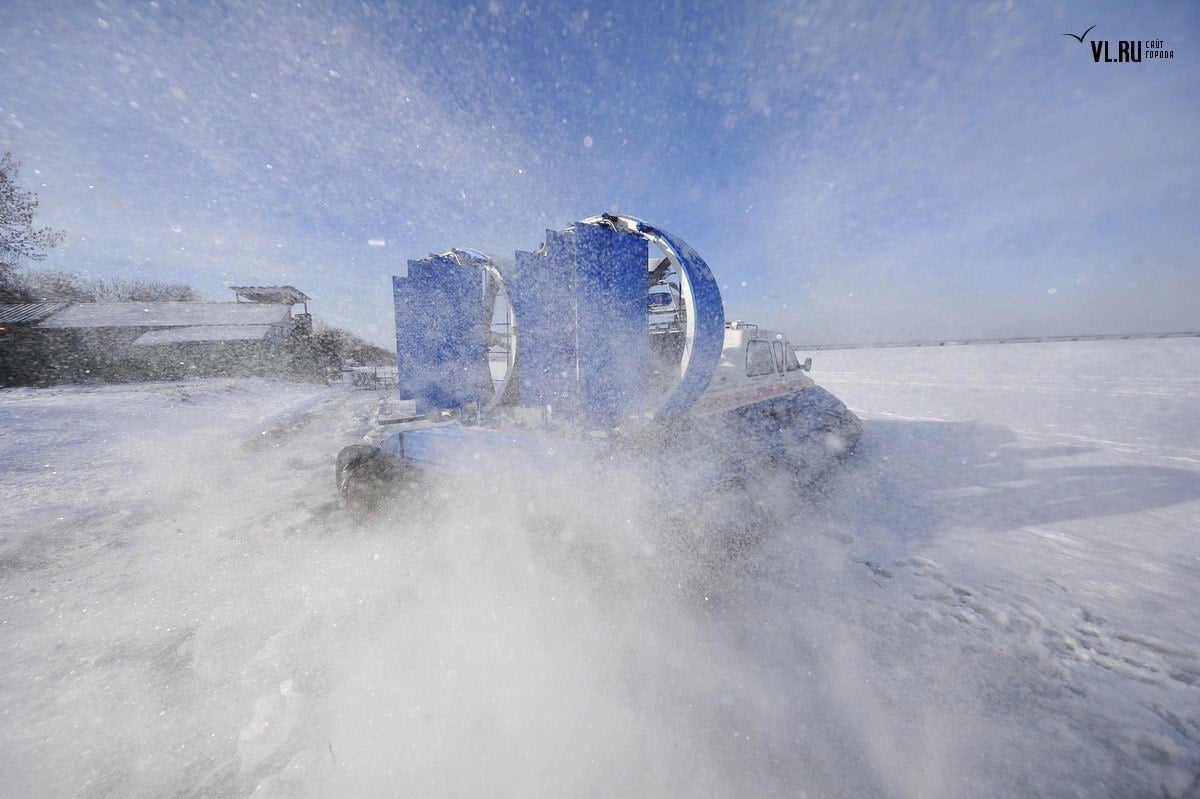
[336,215,862,509]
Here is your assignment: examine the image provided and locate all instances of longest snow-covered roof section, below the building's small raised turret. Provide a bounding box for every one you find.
[38,302,292,328]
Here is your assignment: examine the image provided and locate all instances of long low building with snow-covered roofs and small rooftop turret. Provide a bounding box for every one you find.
[0,286,312,386]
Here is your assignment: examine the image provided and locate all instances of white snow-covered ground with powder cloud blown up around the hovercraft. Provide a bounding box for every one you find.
[0,340,1200,797]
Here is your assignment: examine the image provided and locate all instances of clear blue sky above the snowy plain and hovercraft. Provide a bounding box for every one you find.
[0,0,1200,344]
